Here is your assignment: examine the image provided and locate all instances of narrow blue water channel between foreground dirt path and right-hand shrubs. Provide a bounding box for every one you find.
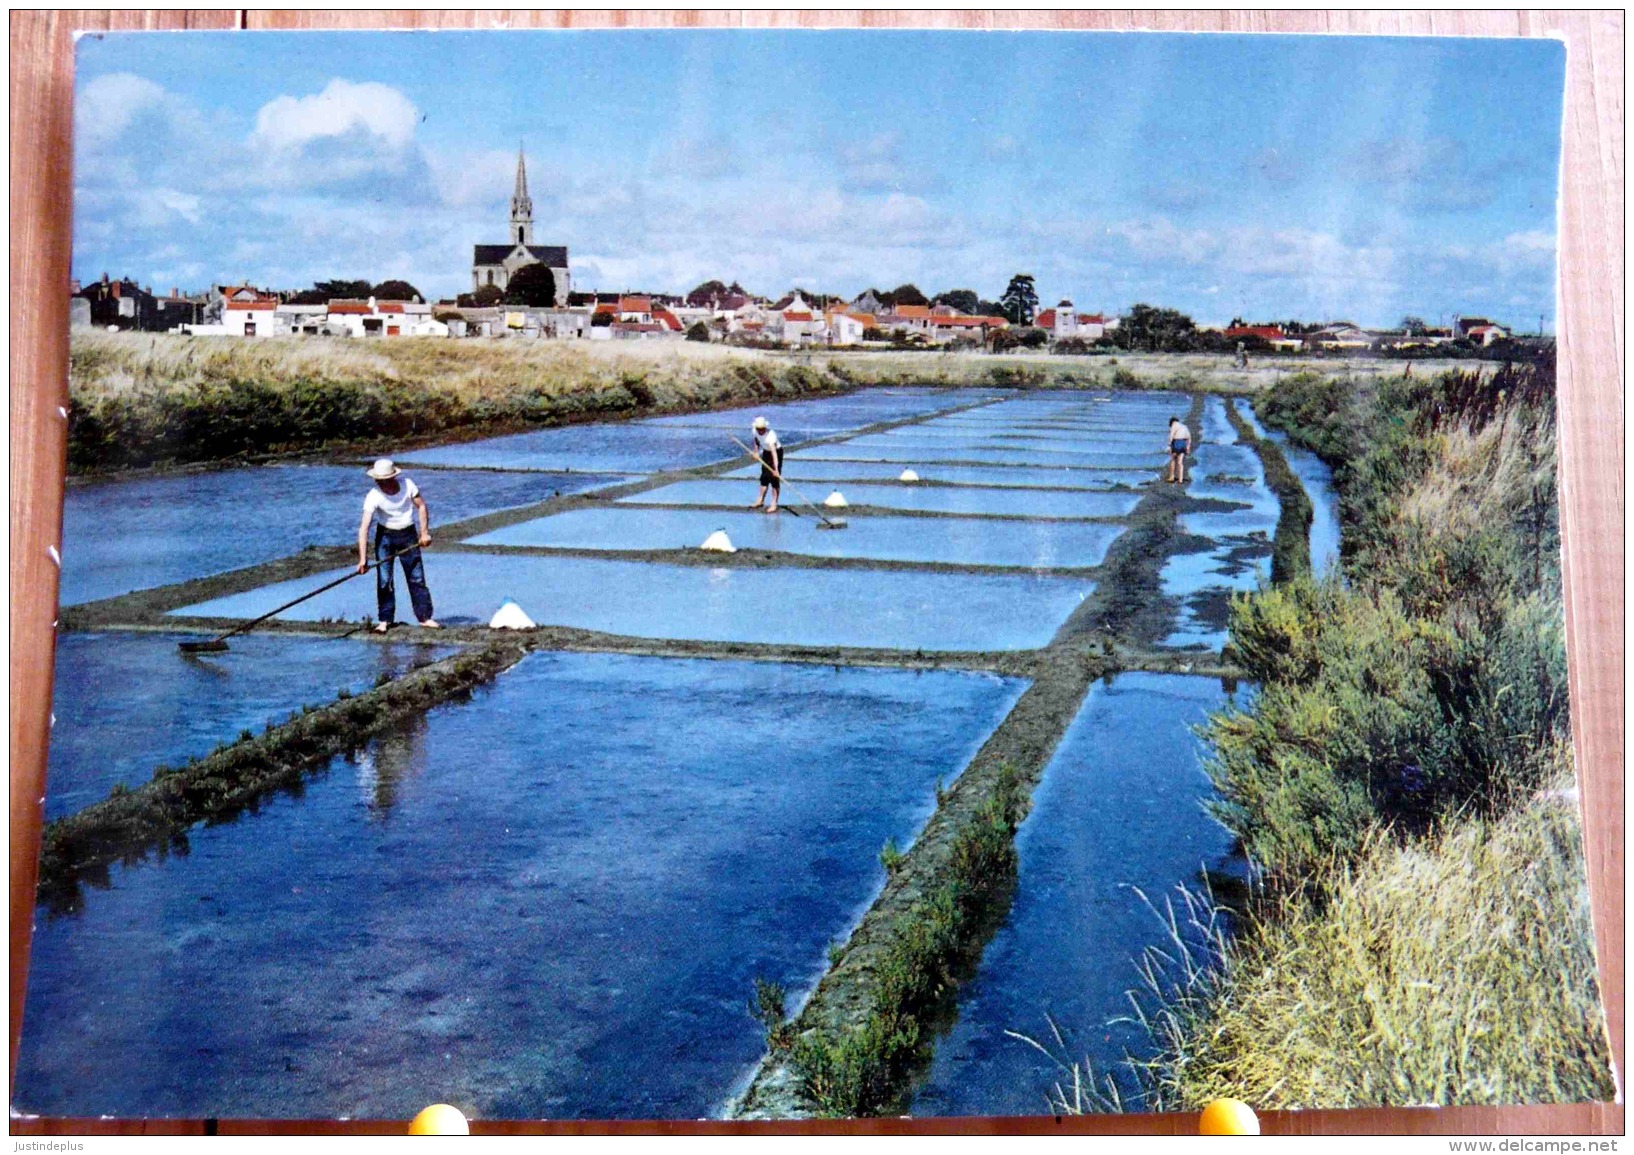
[913,673,1232,1116]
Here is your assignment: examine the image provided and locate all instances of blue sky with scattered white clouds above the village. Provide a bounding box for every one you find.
[74,31,1565,330]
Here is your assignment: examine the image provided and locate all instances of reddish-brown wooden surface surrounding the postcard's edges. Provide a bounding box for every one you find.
[10,10,1626,1134]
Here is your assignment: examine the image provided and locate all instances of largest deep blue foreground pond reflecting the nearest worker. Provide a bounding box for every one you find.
[13,653,1023,1119]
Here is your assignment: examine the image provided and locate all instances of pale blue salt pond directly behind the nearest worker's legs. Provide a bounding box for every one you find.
[173,551,1095,650]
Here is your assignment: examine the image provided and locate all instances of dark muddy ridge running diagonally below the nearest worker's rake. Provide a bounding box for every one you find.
[39,642,525,905]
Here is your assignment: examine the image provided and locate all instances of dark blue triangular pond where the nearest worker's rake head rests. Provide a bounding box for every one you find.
[46,634,458,822]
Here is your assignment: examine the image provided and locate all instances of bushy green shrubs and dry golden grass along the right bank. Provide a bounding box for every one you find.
[1056,366,1614,1111]
